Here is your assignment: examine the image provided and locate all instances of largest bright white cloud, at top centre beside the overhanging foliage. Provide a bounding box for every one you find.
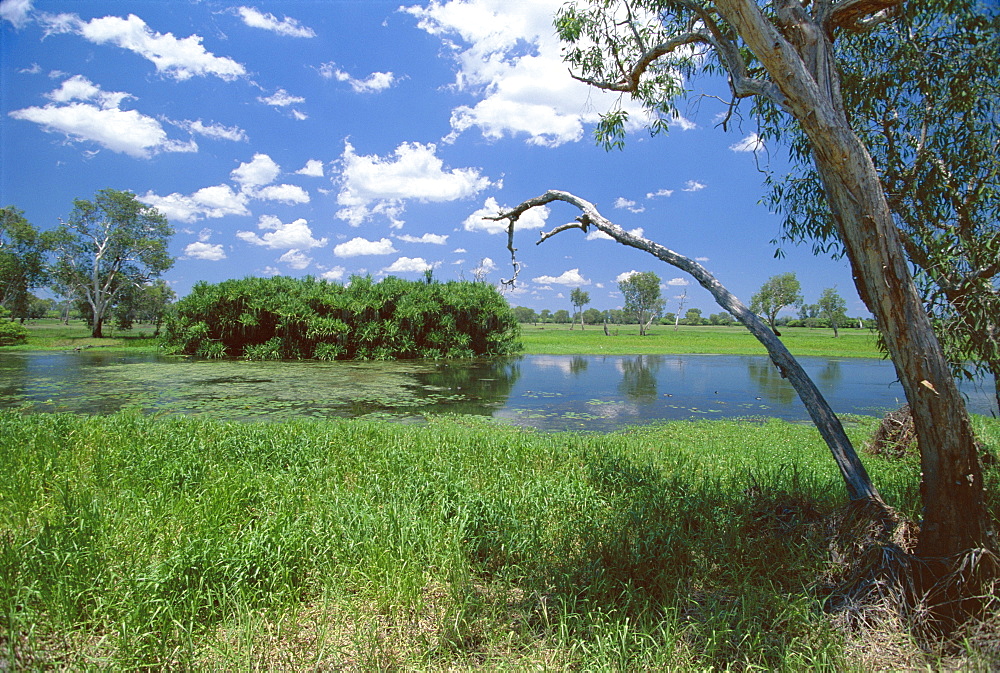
[402,0,684,147]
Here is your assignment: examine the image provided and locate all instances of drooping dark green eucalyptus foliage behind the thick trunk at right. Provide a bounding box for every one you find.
[762,0,1000,414]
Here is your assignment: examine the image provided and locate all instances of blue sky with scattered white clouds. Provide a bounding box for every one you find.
[0,0,868,315]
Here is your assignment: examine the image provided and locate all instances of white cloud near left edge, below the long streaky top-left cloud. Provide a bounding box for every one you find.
[8,75,198,159]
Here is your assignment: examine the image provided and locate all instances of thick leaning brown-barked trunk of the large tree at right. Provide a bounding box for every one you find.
[717,0,988,557]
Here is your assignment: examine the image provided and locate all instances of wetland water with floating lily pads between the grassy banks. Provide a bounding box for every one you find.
[0,351,993,432]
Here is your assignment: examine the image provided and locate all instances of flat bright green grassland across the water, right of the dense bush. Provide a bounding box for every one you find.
[521,324,882,358]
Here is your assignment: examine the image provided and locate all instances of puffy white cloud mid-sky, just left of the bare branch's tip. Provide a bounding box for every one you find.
[337,143,491,227]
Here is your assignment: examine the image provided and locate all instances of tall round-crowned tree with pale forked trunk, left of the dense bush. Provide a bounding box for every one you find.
[53,189,174,338]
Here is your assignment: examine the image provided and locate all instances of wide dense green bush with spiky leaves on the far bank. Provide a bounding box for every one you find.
[165,276,521,360]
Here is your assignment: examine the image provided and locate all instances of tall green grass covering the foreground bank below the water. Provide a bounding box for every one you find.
[0,412,1000,671]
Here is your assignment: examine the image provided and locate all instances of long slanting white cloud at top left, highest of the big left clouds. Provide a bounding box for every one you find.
[57,14,246,81]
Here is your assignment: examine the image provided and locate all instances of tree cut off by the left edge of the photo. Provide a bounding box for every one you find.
[0,206,49,322]
